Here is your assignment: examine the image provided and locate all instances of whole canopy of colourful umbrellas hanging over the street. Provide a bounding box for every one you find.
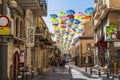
[50,7,94,50]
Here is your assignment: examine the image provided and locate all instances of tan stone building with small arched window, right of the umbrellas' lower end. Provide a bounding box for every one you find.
[70,21,94,66]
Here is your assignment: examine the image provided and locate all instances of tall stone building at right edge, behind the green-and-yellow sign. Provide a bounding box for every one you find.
[94,0,120,69]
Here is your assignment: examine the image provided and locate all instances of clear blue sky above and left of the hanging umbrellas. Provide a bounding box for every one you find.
[43,0,94,33]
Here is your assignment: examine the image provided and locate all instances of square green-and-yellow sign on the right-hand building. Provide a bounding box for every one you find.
[105,25,117,41]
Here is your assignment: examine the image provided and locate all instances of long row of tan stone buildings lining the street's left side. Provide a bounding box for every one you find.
[0,0,52,80]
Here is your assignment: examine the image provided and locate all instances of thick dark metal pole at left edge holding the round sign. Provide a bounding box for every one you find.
[0,0,8,80]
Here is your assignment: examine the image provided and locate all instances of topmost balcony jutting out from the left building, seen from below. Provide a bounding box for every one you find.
[17,0,47,16]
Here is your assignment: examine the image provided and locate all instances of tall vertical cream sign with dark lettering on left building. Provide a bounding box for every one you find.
[26,27,35,47]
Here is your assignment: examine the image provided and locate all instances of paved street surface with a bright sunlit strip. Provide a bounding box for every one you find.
[30,65,118,80]
